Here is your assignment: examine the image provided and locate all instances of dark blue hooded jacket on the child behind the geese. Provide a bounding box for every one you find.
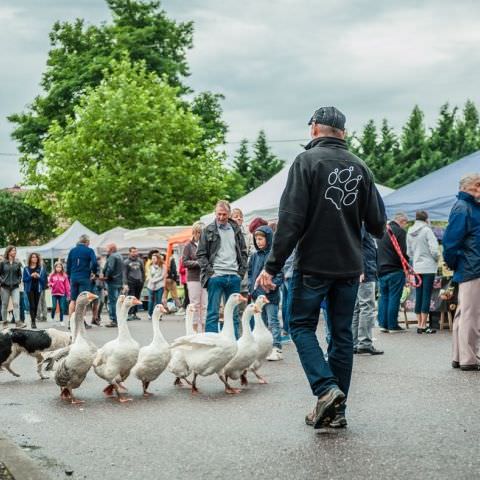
[248,225,283,304]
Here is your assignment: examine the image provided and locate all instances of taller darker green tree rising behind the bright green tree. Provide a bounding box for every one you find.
[9,0,193,173]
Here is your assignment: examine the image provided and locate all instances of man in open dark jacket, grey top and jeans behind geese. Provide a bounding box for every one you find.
[197,200,247,337]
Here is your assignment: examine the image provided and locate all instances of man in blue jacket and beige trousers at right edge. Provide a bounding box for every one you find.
[442,173,480,370]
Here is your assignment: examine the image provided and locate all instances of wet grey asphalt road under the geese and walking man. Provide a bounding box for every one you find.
[0,317,480,480]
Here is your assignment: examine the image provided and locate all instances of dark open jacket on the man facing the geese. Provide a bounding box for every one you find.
[197,220,248,287]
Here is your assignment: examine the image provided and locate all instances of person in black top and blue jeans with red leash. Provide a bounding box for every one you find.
[377,213,408,333]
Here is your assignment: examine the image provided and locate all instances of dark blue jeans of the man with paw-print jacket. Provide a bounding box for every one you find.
[290,271,358,404]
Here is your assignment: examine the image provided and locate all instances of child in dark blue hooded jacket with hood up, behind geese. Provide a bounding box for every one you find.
[248,225,283,361]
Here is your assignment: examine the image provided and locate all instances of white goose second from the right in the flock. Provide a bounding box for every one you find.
[223,303,258,392]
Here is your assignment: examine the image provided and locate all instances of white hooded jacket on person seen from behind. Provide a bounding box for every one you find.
[407,220,440,273]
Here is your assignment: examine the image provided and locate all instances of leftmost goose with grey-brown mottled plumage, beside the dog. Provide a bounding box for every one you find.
[55,292,97,404]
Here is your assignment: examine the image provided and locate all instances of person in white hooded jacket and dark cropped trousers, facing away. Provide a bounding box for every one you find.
[407,210,440,333]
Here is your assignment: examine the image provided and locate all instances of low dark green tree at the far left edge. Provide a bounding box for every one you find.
[0,191,55,246]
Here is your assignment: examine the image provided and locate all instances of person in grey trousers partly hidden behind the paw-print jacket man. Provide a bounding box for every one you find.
[352,229,383,355]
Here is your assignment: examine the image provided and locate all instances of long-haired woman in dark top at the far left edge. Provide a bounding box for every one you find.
[0,245,23,326]
